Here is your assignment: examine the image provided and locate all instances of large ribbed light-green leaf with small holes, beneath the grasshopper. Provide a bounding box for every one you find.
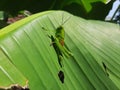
[0,11,120,90]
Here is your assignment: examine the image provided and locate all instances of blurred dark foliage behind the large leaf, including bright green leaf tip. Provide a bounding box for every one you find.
[0,0,115,28]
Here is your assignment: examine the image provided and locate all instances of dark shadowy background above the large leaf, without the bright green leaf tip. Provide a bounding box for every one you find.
[0,0,115,20]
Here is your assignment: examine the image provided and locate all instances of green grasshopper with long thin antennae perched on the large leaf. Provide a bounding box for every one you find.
[43,14,73,67]
